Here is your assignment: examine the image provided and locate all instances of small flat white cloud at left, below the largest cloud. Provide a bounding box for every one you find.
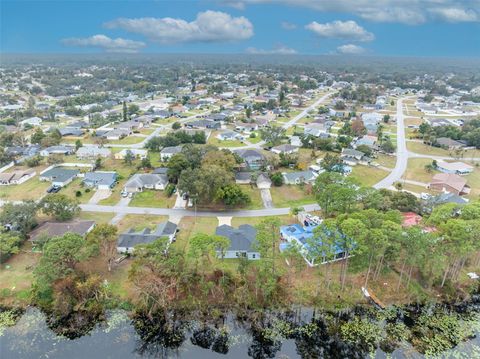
[62,35,146,53]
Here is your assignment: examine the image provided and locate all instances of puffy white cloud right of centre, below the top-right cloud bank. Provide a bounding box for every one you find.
[305,20,375,41]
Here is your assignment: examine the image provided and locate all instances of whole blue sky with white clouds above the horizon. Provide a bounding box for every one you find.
[0,0,480,57]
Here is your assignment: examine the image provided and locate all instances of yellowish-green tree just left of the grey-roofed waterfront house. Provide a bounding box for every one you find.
[87,224,117,272]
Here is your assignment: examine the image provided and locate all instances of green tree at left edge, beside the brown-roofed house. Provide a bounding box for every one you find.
[0,201,37,236]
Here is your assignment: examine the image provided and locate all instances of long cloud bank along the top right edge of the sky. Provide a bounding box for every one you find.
[226,0,480,25]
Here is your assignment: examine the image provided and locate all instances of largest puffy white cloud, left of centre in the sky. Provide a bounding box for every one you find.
[105,10,253,44]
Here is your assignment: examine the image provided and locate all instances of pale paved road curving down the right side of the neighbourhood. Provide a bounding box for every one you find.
[373,98,408,189]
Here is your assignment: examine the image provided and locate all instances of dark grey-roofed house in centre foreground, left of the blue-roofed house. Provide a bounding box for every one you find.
[215,224,260,260]
